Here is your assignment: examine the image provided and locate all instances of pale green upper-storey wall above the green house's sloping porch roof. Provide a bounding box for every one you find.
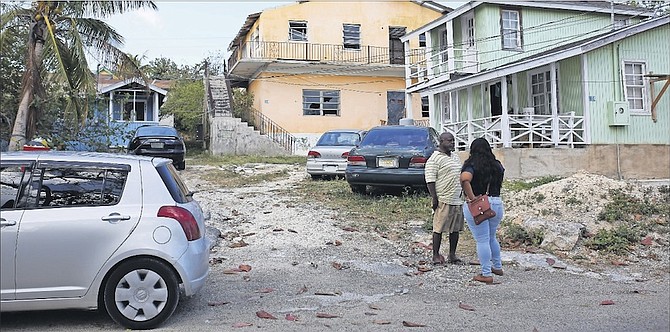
[472,4,624,70]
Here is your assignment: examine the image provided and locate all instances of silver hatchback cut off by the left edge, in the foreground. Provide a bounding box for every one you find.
[0,151,209,329]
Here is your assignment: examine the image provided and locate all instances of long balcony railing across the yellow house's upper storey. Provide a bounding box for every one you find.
[228,41,422,68]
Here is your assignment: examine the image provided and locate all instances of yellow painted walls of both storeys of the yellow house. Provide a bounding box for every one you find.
[245,1,441,134]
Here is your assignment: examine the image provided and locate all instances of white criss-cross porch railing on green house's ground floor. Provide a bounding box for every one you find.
[444,112,587,149]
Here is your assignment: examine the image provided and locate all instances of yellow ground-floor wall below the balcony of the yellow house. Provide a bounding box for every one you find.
[249,73,421,133]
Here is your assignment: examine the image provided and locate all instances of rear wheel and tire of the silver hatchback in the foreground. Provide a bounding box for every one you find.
[103,258,180,330]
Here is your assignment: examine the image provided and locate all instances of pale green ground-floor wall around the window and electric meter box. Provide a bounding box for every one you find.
[585,25,670,145]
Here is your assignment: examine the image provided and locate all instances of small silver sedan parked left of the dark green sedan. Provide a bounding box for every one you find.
[307,129,365,179]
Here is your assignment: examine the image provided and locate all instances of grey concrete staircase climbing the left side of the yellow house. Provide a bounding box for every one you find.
[205,76,293,156]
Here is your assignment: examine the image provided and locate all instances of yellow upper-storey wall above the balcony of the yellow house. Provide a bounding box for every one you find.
[251,1,441,52]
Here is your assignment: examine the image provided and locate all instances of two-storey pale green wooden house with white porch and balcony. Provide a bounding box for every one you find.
[401,1,670,148]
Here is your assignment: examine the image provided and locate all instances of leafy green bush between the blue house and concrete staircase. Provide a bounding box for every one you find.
[161,79,205,134]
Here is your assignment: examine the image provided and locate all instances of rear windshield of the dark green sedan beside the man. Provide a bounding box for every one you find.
[359,128,428,148]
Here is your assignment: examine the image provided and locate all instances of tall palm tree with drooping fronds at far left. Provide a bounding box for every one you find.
[0,1,158,150]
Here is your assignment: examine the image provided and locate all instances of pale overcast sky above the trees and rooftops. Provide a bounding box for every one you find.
[105,0,464,66]
